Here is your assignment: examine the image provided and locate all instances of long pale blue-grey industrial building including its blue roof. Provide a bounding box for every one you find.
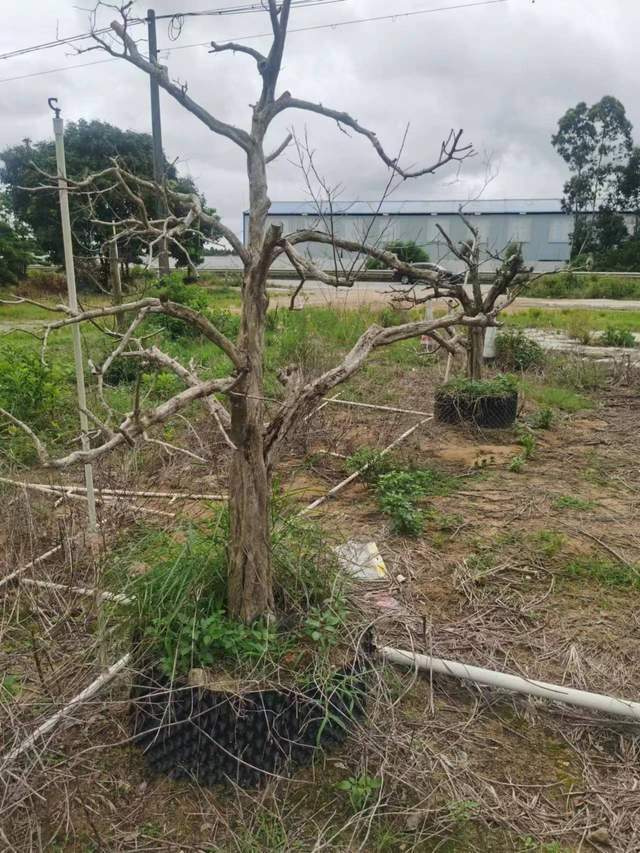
[243,198,573,271]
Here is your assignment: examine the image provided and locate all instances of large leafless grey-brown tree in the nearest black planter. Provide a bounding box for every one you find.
[5,0,493,622]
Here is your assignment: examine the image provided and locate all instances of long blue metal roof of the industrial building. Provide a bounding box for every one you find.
[245,198,562,216]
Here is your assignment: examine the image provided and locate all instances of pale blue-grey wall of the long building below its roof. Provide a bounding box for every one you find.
[245,213,573,271]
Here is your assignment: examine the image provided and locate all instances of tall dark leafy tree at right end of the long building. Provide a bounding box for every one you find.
[551,95,640,271]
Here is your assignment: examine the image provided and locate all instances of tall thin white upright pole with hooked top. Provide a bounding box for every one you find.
[49,98,97,533]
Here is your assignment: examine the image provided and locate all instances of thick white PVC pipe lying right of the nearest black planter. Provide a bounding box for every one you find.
[380,646,640,721]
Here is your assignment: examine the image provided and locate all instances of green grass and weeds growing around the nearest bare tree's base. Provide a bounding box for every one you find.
[105,501,357,679]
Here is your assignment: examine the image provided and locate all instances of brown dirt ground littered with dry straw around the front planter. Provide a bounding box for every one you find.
[0,354,640,853]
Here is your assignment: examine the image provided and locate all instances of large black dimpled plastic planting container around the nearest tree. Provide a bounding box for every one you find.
[132,657,367,788]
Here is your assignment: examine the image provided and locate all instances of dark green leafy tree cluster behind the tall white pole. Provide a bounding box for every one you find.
[0,120,218,287]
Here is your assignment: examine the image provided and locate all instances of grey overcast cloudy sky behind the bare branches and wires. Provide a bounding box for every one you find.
[0,0,640,236]
